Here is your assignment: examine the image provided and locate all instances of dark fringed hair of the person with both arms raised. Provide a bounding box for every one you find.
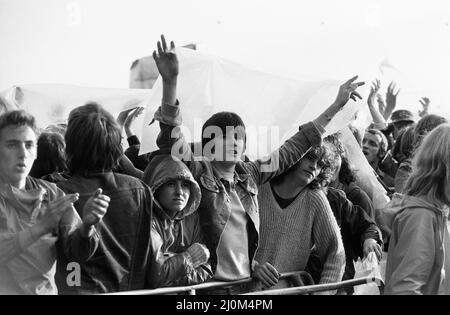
[202,112,246,149]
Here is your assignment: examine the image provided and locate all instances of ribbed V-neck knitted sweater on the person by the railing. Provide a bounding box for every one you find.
[256,183,345,284]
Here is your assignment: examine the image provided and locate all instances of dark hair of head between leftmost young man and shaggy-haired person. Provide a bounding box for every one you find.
[30,132,68,178]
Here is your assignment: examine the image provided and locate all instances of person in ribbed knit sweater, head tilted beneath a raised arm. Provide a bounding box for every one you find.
[254,146,345,287]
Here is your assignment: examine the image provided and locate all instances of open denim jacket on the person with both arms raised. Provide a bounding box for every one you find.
[154,104,324,272]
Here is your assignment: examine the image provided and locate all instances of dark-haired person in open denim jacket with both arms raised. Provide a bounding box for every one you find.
[153,37,363,292]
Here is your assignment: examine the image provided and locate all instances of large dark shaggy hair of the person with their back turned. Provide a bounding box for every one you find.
[65,103,123,174]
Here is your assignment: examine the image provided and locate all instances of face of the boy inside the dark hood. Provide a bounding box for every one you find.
[157,179,191,217]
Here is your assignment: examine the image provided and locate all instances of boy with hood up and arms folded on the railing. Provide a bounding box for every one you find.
[143,155,212,287]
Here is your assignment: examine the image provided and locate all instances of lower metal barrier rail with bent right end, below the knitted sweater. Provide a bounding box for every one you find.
[243,277,384,295]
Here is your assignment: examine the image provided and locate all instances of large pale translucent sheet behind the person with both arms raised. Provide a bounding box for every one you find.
[140,48,367,159]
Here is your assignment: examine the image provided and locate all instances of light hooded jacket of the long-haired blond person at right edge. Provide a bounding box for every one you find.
[385,196,449,295]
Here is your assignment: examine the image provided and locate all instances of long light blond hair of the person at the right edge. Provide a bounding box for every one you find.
[405,124,450,206]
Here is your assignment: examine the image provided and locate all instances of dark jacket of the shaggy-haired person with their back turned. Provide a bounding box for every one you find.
[57,172,153,294]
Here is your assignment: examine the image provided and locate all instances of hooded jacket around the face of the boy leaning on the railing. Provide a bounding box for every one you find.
[144,155,212,287]
